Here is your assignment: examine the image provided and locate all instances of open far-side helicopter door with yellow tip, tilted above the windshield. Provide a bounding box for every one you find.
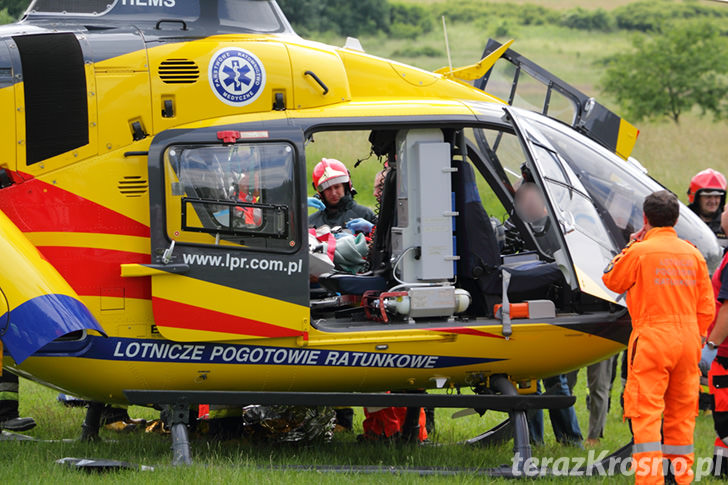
[475,39,639,160]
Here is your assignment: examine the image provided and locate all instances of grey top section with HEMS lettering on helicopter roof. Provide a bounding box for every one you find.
[26,0,292,33]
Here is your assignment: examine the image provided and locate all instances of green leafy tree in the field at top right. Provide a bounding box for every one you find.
[602,22,728,123]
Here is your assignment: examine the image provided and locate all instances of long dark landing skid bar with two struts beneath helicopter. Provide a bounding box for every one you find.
[124,375,575,476]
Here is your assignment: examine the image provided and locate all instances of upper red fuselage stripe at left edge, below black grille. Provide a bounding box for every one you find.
[0,179,149,237]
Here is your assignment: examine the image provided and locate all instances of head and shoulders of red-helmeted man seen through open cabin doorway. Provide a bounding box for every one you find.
[308,158,377,234]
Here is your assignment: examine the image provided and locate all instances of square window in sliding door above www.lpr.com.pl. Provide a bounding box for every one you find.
[165,143,295,249]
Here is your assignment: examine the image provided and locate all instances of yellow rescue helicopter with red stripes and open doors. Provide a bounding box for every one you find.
[0,0,720,468]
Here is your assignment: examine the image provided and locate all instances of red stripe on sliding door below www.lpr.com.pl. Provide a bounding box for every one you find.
[152,297,303,338]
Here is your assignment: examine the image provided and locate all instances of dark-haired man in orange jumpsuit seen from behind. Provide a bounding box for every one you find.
[602,190,715,484]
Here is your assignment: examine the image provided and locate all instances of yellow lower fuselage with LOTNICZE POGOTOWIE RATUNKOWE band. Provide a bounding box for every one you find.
[5,324,623,403]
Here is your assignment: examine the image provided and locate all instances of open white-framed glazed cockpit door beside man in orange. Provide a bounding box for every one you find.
[504,108,624,305]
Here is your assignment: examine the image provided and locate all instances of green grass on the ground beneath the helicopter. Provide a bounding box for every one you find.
[0,371,724,485]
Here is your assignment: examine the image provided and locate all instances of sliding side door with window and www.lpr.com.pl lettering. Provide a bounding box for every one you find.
[123,129,309,341]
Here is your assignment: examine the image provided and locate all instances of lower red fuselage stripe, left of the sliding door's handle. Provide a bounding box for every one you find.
[38,246,152,300]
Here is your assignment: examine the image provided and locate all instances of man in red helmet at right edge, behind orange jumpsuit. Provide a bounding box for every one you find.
[688,168,728,247]
